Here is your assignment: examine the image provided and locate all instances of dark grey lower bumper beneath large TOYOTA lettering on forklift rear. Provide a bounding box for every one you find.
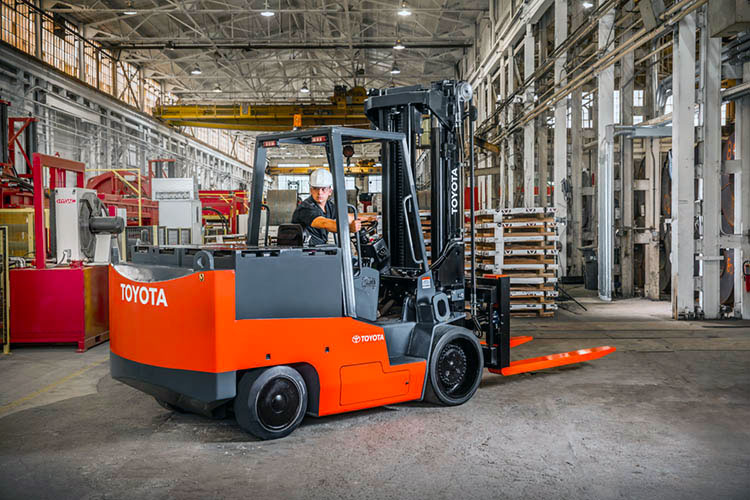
[109,352,237,403]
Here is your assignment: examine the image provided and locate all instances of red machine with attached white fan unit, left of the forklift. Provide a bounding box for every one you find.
[9,153,124,352]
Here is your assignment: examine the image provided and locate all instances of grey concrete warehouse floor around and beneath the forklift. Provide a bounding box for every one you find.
[0,292,750,500]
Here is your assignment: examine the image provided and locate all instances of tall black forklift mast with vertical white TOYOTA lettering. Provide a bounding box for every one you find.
[365,80,472,312]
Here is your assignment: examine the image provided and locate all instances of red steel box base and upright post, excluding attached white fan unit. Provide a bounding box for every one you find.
[9,153,109,352]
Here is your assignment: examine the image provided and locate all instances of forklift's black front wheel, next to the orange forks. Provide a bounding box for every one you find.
[424,326,484,406]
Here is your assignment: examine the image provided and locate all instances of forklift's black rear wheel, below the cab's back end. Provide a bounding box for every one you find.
[234,366,307,439]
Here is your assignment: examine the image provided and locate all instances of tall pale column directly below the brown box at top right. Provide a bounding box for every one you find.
[700,12,721,319]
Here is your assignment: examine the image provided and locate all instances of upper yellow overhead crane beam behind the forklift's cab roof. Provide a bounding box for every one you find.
[153,86,370,132]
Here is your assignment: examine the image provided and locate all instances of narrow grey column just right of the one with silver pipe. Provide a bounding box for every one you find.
[620,10,635,297]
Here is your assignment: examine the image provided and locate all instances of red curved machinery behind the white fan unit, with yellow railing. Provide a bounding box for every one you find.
[86,169,159,226]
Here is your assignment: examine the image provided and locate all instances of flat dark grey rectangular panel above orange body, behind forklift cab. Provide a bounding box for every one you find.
[235,247,343,319]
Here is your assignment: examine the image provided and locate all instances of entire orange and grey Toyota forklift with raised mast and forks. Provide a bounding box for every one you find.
[109,81,615,439]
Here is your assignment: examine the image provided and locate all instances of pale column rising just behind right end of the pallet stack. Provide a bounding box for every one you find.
[552,0,568,276]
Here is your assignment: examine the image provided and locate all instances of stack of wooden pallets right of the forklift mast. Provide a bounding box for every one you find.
[466,207,559,317]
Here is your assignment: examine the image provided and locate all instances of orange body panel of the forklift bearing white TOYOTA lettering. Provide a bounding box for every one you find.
[109,266,426,416]
